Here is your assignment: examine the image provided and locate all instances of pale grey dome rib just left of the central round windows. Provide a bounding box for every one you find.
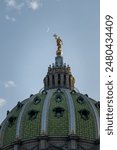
[41,90,54,134]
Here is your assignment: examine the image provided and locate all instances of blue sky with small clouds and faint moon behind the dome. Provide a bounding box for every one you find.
[0,0,100,122]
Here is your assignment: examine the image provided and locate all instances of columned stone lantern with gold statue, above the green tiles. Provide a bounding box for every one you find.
[44,34,75,90]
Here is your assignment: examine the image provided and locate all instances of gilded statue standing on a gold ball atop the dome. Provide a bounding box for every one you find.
[53,34,63,56]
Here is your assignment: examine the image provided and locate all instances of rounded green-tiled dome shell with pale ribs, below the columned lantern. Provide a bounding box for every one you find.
[1,89,99,146]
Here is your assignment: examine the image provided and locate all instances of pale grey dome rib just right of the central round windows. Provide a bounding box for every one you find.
[64,89,76,134]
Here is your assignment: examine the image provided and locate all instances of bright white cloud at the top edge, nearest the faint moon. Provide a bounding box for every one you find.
[27,0,41,11]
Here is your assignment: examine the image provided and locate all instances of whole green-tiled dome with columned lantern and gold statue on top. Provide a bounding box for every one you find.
[0,36,100,150]
